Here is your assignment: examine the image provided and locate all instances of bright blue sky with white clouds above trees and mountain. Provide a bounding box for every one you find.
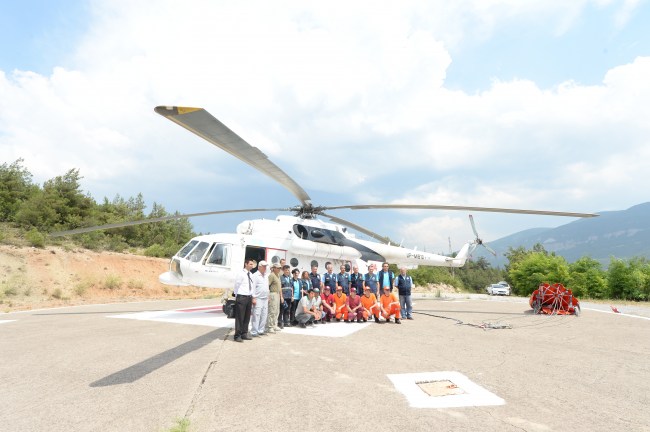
[0,0,650,250]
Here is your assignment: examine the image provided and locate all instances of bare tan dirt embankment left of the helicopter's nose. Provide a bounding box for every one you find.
[0,245,221,312]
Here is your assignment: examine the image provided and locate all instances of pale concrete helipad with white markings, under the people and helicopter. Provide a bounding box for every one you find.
[0,299,650,431]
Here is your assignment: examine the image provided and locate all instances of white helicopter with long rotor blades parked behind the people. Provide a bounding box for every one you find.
[52,106,598,288]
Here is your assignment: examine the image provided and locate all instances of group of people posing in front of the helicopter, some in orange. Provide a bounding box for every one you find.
[234,259,414,342]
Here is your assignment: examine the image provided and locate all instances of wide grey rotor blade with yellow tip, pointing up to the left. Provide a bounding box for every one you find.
[155,106,311,207]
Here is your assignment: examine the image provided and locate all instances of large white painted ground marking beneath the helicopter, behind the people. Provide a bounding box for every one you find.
[108,305,369,337]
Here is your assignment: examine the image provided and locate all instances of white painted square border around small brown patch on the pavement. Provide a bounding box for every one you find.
[387,371,506,408]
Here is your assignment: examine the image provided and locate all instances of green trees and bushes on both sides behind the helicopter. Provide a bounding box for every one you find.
[0,159,650,301]
